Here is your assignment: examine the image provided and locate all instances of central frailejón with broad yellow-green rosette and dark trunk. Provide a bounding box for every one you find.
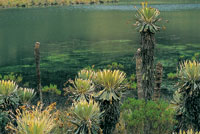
[95,70,126,134]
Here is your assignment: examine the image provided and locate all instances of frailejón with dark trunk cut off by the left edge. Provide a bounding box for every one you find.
[0,80,20,134]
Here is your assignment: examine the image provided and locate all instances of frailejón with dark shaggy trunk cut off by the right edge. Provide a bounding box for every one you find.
[176,61,200,131]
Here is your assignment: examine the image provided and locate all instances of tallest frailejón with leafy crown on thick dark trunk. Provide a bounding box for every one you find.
[135,2,161,100]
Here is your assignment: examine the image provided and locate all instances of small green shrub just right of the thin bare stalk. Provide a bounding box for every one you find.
[42,84,61,95]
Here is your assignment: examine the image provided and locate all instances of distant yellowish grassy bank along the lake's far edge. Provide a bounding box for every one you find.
[0,0,200,8]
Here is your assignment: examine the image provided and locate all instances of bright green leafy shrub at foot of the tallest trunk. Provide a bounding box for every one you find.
[121,98,176,134]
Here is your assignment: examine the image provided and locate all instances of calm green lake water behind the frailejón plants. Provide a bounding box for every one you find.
[0,4,200,90]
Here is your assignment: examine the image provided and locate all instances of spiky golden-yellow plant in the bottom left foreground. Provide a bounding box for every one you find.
[8,103,56,134]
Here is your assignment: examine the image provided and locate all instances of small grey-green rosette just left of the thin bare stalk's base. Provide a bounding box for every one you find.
[17,88,36,104]
